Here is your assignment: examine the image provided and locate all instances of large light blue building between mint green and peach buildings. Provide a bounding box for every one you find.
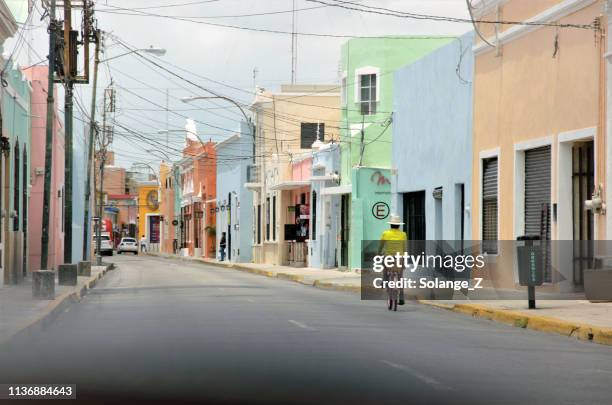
[391,33,474,240]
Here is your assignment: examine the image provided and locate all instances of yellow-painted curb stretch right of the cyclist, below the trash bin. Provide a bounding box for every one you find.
[418,300,612,346]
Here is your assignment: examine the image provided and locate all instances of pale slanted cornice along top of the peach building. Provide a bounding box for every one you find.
[472,0,597,56]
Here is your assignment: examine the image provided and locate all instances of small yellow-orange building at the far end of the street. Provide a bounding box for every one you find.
[137,181,161,252]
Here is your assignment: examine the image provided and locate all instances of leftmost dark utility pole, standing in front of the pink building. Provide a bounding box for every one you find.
[40,0,57,270]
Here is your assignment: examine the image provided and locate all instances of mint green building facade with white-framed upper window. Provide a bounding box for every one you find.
[339,36,454,268]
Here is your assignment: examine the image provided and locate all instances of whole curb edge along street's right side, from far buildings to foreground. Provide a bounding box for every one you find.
[147,252,612,346]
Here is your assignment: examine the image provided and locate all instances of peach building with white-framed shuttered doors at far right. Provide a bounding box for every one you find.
[471,0,610,289]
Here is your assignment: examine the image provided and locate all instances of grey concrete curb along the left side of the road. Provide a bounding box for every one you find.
[0,264,115,345]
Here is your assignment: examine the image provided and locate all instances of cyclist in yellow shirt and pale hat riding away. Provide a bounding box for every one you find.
[379,214,408,311]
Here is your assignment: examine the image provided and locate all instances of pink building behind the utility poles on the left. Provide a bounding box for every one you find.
[24,66,64,271]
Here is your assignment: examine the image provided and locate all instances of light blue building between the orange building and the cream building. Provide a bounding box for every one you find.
[216,121,253,263]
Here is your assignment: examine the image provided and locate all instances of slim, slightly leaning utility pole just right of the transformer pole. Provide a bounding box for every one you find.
[83,30,102,260]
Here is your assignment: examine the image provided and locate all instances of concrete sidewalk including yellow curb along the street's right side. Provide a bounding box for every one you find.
[152,253,612,345]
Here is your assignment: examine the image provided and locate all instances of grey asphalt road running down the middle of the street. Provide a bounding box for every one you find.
[0,256,612,405]
